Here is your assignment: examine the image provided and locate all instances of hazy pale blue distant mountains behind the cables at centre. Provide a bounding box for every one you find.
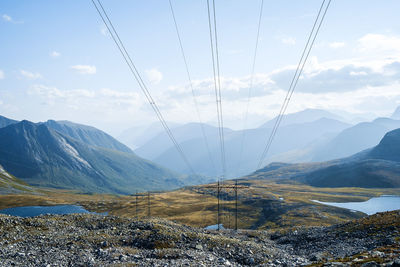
[135,110,351,177]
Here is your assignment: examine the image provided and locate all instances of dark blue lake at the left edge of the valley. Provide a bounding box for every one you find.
[0,205,104,217]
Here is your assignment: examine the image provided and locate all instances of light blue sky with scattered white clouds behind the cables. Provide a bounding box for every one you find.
[0,0,400,136]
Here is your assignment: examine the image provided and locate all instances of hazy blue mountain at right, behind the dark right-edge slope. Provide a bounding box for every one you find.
[312,118,400,161]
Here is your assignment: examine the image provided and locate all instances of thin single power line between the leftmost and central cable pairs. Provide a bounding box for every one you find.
[168,0,216,174]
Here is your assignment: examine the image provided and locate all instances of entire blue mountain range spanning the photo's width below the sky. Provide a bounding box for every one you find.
[0,104,400,194]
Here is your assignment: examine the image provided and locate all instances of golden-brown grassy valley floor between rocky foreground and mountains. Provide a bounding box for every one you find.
[0,182,400,230]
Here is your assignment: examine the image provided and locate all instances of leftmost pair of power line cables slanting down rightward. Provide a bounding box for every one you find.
[91,0,195,174]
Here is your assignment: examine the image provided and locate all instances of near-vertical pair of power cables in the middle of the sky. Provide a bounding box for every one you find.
[207,0,226,181]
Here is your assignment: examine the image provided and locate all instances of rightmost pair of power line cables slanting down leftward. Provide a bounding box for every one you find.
[257,0,331,169]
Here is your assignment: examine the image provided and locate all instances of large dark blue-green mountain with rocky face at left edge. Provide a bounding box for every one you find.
[0,121,184,194]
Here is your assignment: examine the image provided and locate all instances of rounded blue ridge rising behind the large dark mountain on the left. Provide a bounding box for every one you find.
[43,120,133,153]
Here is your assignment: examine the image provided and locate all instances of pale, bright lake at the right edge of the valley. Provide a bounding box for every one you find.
[313,195,400,215]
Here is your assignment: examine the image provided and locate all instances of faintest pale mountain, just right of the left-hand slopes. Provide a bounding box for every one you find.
[117,122,181,149]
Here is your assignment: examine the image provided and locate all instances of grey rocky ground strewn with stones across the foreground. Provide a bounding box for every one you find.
[0,211,400,267]
